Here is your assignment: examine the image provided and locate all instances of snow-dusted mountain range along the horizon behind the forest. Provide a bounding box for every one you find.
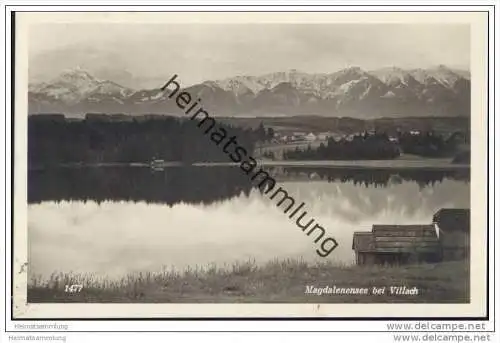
[28,65,470,119]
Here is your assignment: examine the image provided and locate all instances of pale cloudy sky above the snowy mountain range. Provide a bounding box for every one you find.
[29,23,470,84]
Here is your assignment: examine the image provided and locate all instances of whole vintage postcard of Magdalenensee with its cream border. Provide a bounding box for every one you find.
[12,12,488,319]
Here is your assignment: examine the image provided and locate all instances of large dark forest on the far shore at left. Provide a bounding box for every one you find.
[28,115,267,167]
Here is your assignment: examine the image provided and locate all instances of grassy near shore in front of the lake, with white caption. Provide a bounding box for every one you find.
[28,260,469,303]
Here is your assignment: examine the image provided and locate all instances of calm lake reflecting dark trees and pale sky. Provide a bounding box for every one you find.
[28,166,470,279]
